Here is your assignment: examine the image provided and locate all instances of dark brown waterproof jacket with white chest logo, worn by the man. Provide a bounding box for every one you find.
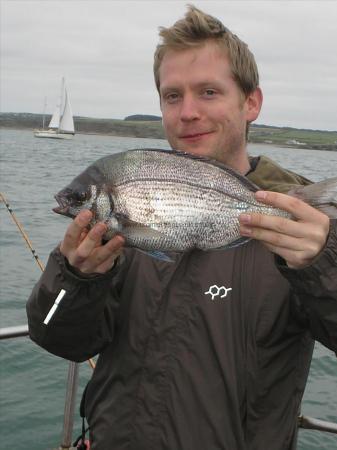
[27,158,337,450]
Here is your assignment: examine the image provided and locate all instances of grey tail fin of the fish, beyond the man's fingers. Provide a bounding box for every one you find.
[288,177,337,219]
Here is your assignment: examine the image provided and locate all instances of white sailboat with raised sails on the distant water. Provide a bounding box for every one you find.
[34,78,75,139]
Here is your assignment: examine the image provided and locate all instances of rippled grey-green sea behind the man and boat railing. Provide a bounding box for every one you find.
[0,130,337,450]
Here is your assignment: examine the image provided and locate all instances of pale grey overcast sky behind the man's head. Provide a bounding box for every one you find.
[0,0,337,130]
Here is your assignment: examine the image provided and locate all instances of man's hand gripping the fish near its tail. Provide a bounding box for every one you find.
[239,191,329,269]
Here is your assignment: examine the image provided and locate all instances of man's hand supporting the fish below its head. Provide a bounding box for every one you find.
[60,210,124,274]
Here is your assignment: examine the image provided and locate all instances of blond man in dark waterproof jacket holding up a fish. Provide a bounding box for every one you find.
[27,7,337,450]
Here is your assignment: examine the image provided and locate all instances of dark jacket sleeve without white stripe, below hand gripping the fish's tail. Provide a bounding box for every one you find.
[277,220,337,354]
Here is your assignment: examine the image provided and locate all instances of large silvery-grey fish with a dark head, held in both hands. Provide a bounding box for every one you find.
[53,148,337,259]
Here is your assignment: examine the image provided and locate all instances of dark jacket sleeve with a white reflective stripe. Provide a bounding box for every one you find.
[27,248,124,362]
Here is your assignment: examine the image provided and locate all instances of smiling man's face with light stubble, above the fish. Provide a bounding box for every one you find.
[159,42,262,171]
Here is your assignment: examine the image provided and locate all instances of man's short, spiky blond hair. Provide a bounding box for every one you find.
[153,5,259,97]
